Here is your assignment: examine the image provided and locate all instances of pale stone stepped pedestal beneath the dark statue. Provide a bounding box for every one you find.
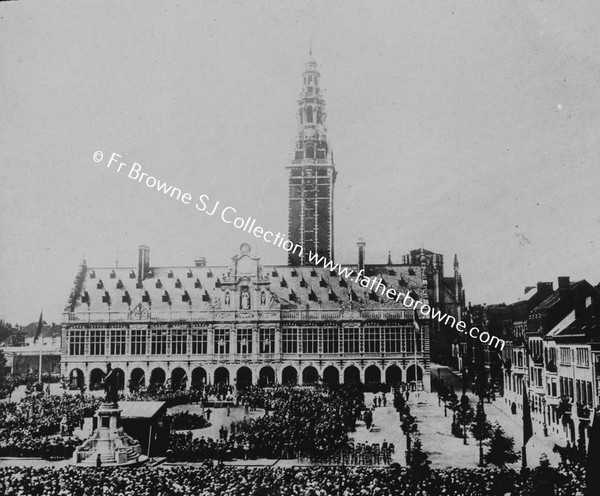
[73,403,148,467]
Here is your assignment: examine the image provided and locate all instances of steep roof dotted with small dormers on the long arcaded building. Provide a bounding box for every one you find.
[66,265,422,312]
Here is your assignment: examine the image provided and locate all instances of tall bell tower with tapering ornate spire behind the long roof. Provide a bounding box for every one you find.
[286,48,336,265]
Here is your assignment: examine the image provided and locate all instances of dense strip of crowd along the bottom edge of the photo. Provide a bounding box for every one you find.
[0,463,584,496]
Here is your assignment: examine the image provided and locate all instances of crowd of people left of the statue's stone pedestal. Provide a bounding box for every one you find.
[0,393,100,459]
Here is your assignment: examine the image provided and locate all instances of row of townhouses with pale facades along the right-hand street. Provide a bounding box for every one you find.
[454,277,600,450]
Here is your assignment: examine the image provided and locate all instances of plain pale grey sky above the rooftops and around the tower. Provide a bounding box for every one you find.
[0,0,600,324]
